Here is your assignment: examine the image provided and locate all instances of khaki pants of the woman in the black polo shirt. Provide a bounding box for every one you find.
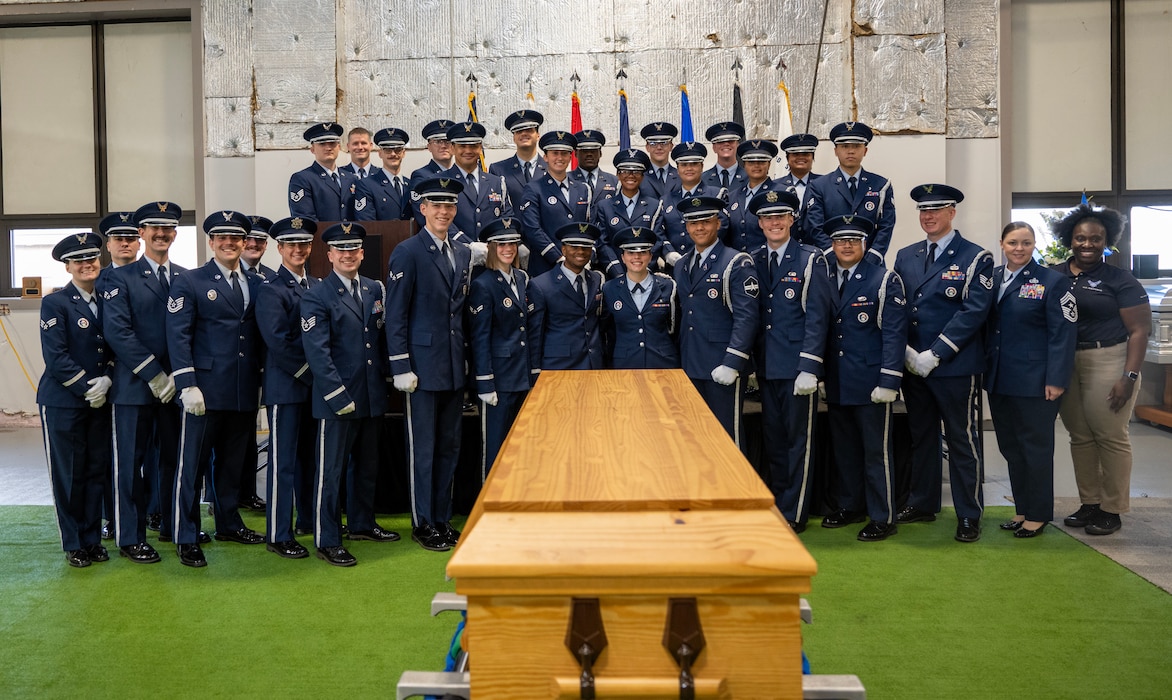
[1061,342,1139,514]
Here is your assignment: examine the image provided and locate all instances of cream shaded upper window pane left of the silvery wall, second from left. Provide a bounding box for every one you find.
[103,22,196,211]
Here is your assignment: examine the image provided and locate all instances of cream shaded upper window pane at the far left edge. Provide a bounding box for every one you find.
[0,26,95,213]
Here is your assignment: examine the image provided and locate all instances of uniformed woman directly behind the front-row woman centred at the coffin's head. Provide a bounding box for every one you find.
[594,149,663,279]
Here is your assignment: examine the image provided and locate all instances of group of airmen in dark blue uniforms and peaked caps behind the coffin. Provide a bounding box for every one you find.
[38,109,1017,566]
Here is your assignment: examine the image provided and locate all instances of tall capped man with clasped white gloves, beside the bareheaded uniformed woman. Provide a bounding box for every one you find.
[890,177,994,542]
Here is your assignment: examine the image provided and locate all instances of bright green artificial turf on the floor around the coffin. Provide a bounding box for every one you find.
[0,507,1172,700]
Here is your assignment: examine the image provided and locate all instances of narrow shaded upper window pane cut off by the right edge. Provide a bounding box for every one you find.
[1123,0,1172,189]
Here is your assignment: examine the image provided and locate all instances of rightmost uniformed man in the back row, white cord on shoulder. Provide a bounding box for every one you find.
[803,122,906,264]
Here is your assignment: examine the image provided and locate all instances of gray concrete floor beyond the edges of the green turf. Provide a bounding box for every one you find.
[0,415,1172,593]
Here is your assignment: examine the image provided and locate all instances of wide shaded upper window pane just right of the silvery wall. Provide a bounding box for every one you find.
[1008,0,1111,192]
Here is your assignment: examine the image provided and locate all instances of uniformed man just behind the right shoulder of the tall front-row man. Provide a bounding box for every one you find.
[440,122,513,246]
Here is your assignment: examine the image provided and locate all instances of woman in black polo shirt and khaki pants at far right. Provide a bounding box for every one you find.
[1054,204,1152,535]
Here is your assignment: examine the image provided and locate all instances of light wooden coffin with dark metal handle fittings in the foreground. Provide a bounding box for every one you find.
[448,369,817,700]
